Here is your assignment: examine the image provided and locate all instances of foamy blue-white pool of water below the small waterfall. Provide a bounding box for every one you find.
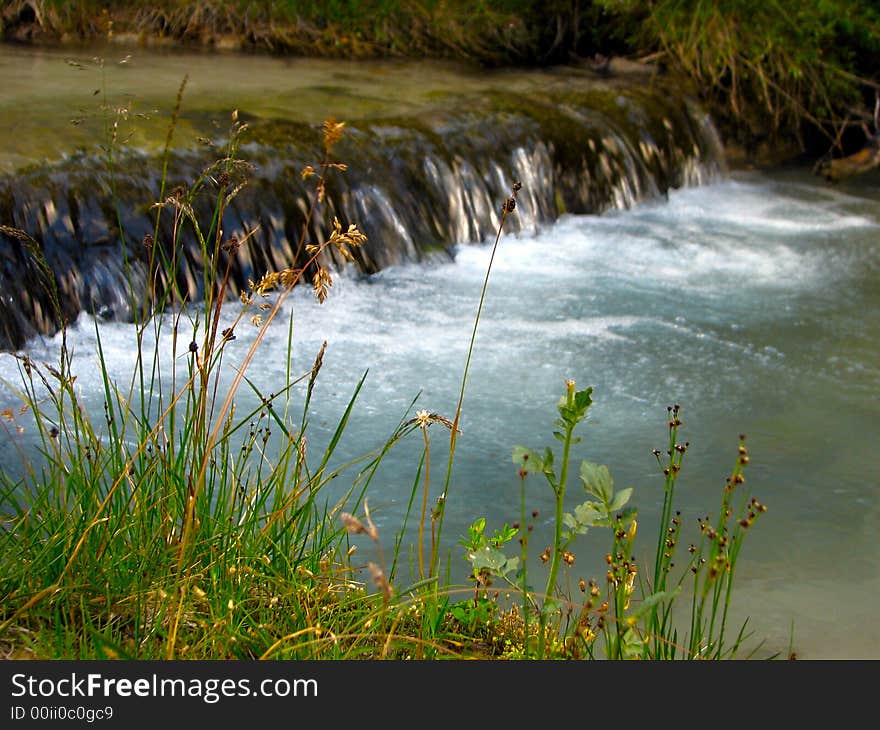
[0,45,880,658]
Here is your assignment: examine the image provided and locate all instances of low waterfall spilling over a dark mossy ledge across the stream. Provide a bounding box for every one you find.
[0,87,725,350]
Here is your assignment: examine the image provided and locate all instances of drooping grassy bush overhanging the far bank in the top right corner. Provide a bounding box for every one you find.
[601,0,880,161]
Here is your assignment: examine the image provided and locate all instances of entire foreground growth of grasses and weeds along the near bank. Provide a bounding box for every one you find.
[0,80,765,659]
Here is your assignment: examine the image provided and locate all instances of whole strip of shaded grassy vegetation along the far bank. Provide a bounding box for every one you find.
[0,0,880,159]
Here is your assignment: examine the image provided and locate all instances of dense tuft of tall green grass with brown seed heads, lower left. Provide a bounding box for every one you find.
[0,86,426,659]
